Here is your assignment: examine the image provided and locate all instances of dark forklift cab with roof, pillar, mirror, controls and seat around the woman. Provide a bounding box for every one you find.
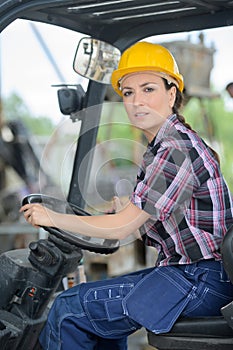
[0,0,233,350]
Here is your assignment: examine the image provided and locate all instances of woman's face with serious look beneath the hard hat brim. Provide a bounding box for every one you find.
[121,72,176,141]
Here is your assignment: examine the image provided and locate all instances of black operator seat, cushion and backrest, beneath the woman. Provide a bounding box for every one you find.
[148,226,233,350]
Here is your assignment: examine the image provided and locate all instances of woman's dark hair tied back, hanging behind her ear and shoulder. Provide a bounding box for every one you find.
[162,78,220,164]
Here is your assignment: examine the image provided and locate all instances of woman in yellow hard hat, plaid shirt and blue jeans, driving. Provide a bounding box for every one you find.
[21,42,233,350]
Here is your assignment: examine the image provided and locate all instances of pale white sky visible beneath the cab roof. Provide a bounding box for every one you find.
[0,20,233,123]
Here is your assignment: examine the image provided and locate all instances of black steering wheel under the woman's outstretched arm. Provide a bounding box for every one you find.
[22,194,119,254]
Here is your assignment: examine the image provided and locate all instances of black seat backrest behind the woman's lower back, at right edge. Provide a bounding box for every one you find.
[221,225,233,283]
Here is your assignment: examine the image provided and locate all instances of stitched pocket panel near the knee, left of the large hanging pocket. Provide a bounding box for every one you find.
[84,284,136,337]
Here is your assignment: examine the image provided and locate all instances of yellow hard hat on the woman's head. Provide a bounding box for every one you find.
[111,41,184,96]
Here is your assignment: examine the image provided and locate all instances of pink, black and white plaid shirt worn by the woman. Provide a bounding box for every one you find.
[131,115,233,266]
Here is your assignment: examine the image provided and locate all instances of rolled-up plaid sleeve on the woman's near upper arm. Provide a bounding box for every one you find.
[131,147,194,221]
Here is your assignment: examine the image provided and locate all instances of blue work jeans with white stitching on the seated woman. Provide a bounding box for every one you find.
[40,261,233,350]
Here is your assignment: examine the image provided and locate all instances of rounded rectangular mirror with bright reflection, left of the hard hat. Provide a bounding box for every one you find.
[73,38,121,84]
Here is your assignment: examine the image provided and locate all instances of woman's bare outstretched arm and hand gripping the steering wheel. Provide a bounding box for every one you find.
[20,203,150,240]
